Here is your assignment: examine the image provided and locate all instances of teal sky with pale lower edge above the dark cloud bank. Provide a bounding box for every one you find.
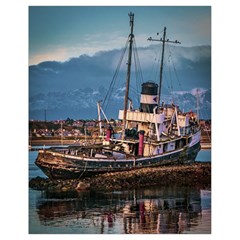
[29,6,211,65]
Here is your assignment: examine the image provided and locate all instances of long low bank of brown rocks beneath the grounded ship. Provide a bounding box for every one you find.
[29,163,211,191]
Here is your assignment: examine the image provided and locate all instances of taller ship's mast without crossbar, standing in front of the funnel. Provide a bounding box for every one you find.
[122,12,134,140]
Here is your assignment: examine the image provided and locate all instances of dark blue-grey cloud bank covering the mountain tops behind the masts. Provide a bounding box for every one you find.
[29,45,211,99]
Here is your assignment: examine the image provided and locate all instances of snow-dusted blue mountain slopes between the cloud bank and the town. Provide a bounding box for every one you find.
[29,88,211,120]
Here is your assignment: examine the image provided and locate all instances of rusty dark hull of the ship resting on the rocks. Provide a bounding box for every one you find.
[35,135,201,179]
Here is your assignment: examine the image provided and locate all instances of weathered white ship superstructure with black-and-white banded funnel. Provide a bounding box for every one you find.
[116,82,199,156]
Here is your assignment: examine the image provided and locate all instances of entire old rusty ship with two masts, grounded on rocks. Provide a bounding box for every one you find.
[35,12,201,179]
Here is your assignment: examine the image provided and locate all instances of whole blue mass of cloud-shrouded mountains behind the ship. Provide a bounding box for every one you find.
[29,45,211,120]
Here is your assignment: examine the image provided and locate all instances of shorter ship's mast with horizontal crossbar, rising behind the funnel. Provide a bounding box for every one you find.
[148,27,181,106]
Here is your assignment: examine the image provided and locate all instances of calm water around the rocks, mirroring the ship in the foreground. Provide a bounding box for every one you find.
[29,150,211,234]
